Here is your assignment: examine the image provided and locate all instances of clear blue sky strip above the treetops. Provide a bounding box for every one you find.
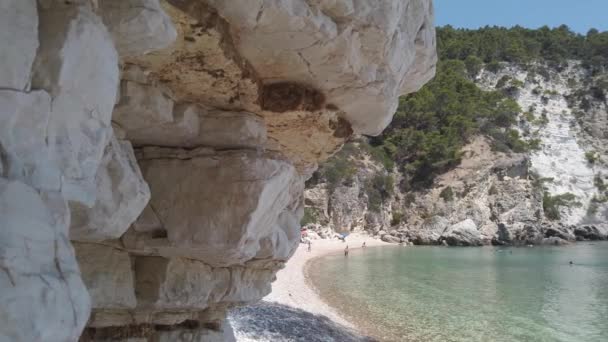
[434,0,608,33]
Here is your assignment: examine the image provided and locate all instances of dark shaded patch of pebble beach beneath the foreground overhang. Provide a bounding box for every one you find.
[228,301,375,342]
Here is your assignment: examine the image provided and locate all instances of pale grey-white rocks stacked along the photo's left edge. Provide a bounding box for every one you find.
[0,0,176,342]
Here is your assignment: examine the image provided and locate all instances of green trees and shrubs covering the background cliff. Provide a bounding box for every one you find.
[310,26,608,225]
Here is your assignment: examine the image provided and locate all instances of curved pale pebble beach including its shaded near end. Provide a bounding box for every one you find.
[230,234,390,341]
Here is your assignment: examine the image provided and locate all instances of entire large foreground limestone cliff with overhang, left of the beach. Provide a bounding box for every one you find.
[0,0,436,342]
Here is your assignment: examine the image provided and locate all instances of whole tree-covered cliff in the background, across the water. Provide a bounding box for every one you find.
[304,27,608,245]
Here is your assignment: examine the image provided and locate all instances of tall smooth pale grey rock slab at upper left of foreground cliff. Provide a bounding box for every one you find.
[32,2,118,206]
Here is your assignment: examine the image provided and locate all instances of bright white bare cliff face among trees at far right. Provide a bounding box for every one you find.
[480,62,608,225]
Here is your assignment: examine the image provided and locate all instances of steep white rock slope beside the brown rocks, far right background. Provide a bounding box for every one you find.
[478,61,608,225]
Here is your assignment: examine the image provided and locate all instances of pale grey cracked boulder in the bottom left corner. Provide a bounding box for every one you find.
[0,178,90,342]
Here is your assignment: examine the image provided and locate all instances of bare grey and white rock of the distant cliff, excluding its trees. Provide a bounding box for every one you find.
[305,61,608,246]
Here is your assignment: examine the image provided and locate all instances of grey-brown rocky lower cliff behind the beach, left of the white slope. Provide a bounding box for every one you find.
[305,137,543,246]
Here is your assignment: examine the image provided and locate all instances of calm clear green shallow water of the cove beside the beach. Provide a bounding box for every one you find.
[307,242,608,342]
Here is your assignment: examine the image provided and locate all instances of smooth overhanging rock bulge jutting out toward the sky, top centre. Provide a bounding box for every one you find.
[209,0,435,134]
